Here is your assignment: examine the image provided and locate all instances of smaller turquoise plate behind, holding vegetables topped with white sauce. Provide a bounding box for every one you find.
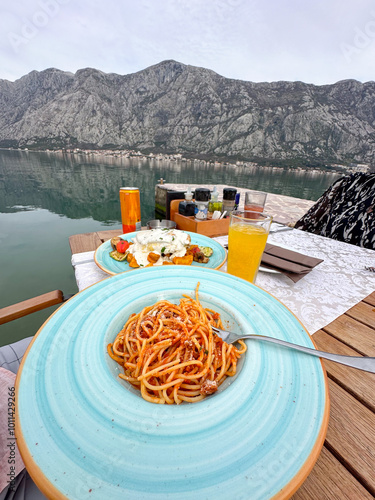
[94,231,227,275]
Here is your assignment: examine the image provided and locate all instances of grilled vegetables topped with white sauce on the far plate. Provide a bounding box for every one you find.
[110,228,213,268]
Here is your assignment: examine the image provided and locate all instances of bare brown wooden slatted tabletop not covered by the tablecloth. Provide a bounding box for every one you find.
[69,228,375,500]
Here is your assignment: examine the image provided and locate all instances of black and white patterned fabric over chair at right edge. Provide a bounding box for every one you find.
[295,173,375,250]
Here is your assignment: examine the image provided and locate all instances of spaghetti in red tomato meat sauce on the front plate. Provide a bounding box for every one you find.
[107,283,247,404]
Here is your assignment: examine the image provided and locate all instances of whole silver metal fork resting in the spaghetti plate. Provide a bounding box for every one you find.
[212,326,375,373]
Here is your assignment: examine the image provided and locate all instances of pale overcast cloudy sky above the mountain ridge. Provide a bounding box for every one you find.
[0,0,375,85]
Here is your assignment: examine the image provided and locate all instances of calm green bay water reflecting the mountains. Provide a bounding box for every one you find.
[0,150,340,345]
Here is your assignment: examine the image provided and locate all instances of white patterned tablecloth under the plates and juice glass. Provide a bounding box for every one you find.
[72,229,375,334]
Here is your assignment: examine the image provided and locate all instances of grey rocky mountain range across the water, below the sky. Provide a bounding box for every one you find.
[0,61,375,163]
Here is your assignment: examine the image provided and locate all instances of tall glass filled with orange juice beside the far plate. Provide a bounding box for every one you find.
[227,211,272,283]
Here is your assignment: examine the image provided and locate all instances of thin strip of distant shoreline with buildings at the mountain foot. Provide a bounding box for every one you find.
[0,148,370,174]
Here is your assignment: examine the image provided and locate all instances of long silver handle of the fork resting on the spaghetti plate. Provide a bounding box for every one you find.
[241,334,375,373]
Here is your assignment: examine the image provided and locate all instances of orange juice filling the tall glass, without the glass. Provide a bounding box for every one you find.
[227,222,268,283]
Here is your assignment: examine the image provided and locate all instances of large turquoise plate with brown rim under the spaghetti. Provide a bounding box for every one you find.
[16,266,329,500]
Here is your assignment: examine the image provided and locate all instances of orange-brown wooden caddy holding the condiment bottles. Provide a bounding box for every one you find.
[170,200,230,238]
